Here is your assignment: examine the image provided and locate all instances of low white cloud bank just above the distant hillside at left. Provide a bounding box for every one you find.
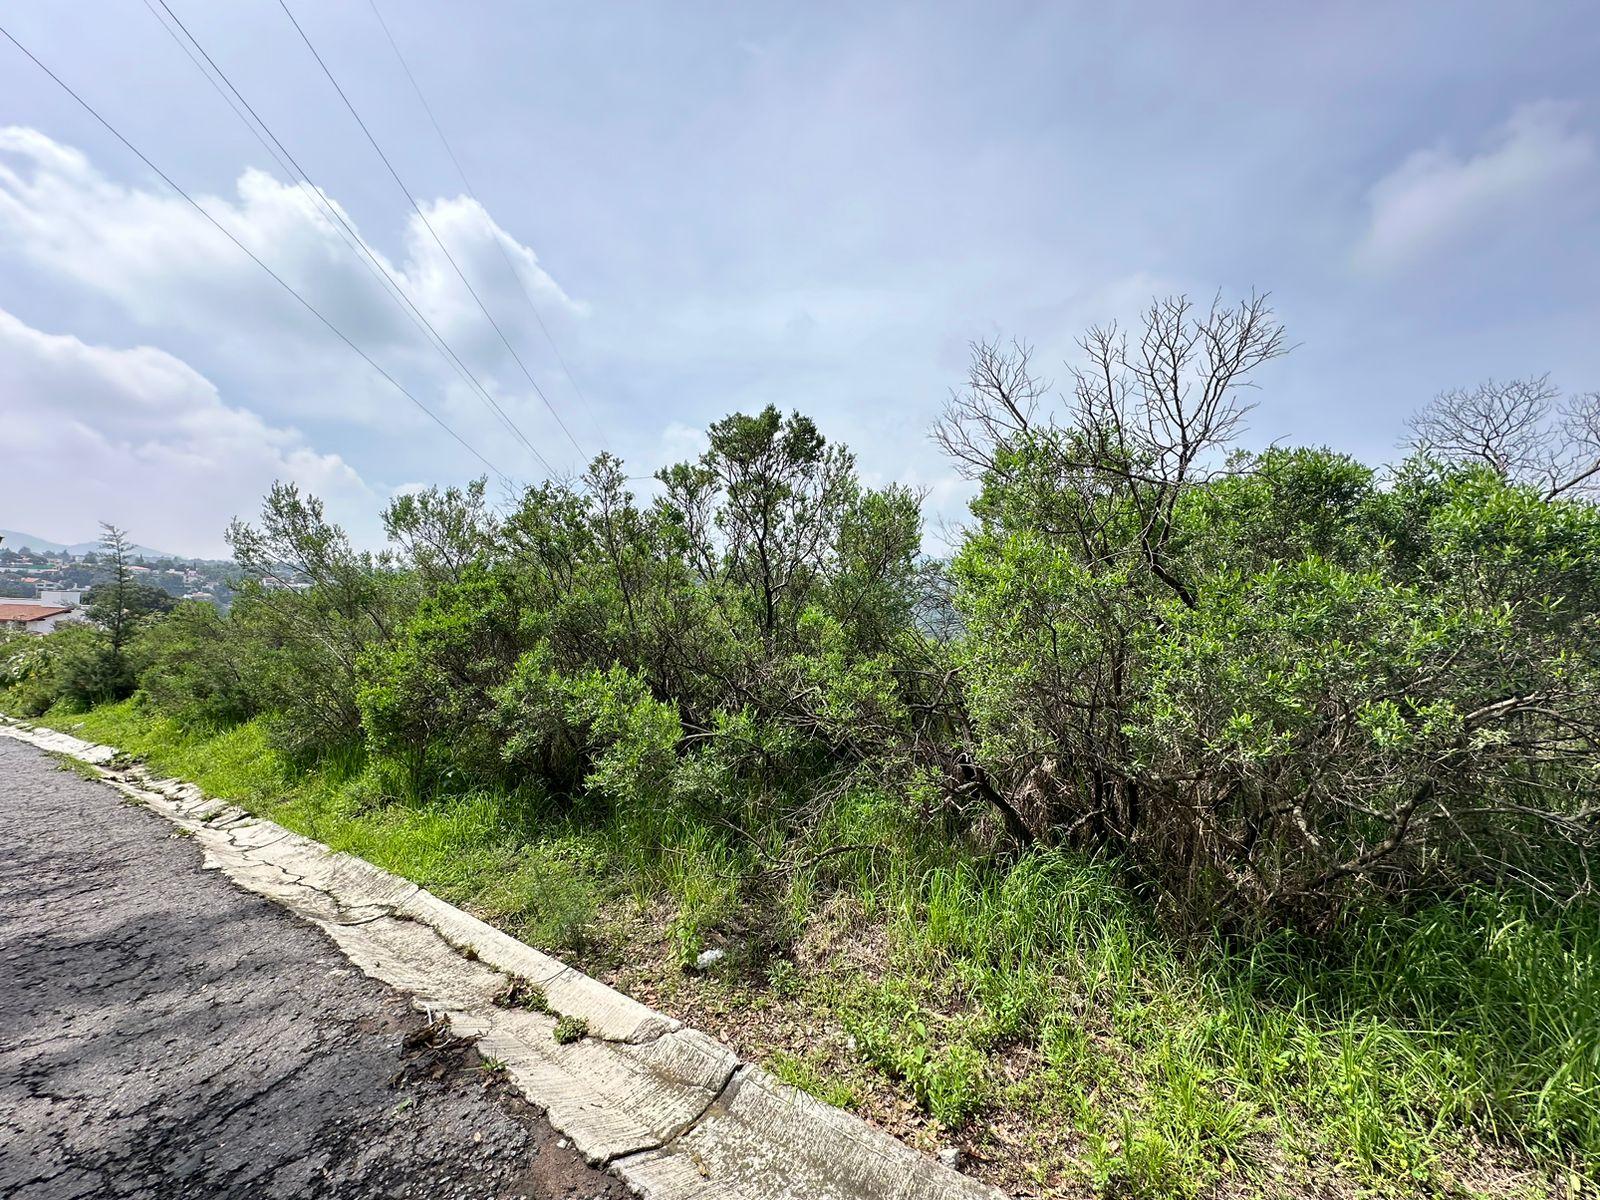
[0,309,378,555]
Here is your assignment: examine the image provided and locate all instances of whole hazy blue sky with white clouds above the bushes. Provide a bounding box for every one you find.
[0,0,1600,555]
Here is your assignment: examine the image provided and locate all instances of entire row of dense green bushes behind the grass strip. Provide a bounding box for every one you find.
[6,299,1600,928]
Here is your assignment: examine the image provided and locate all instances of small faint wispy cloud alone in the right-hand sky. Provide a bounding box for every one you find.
[1355,101,1597,272]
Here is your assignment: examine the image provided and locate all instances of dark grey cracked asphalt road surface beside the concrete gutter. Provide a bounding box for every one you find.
[0,738,629,1200]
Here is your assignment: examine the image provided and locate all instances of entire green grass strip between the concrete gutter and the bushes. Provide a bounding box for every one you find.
[18,702,1600,1197]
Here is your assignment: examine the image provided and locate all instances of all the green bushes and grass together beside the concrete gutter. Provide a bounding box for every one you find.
[0,301,1600,1197]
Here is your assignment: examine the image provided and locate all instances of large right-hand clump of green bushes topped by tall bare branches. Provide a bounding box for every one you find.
[939,299,1600,925]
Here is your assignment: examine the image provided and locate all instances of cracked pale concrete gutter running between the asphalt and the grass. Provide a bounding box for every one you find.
[0,718,1003,1200]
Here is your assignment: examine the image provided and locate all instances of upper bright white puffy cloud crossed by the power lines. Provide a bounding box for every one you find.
[0,126,587,454]
